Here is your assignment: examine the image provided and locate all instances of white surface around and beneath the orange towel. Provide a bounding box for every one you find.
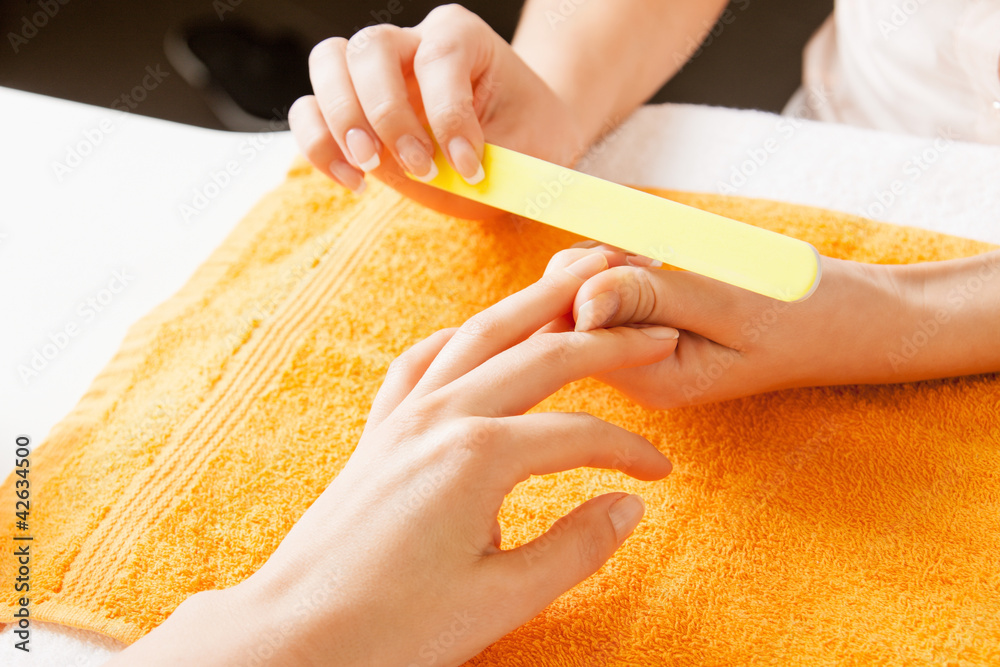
[0,88,1000,667]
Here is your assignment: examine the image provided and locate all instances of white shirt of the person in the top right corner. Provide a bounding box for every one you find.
[785,0,1000,143]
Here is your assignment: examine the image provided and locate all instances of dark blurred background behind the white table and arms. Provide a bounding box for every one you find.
[0,0,833,129]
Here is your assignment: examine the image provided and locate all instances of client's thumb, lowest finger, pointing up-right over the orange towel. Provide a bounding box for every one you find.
[484,493,645,625]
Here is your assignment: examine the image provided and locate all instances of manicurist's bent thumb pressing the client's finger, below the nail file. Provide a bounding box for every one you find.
[573,267,756,347]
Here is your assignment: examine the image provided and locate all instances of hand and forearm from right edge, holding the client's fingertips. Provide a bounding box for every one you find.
[573,252,1000,408]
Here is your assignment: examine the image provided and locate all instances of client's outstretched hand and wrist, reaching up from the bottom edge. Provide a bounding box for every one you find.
[111,249,677,665]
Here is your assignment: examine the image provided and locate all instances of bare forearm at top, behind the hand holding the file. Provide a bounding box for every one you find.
[513,0,726,142]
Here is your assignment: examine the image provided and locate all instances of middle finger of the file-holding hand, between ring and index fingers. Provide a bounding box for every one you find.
[347,24,437,181]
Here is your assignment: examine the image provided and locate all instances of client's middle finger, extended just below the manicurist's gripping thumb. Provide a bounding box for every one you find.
[439,327,679,417]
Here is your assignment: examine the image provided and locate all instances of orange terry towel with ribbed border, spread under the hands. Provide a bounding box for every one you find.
[0,165,1000,665]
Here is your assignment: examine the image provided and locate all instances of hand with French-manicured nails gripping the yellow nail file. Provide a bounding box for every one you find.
[289,5,584,218]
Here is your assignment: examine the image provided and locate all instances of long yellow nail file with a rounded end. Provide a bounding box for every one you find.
[412,144,820,301]
